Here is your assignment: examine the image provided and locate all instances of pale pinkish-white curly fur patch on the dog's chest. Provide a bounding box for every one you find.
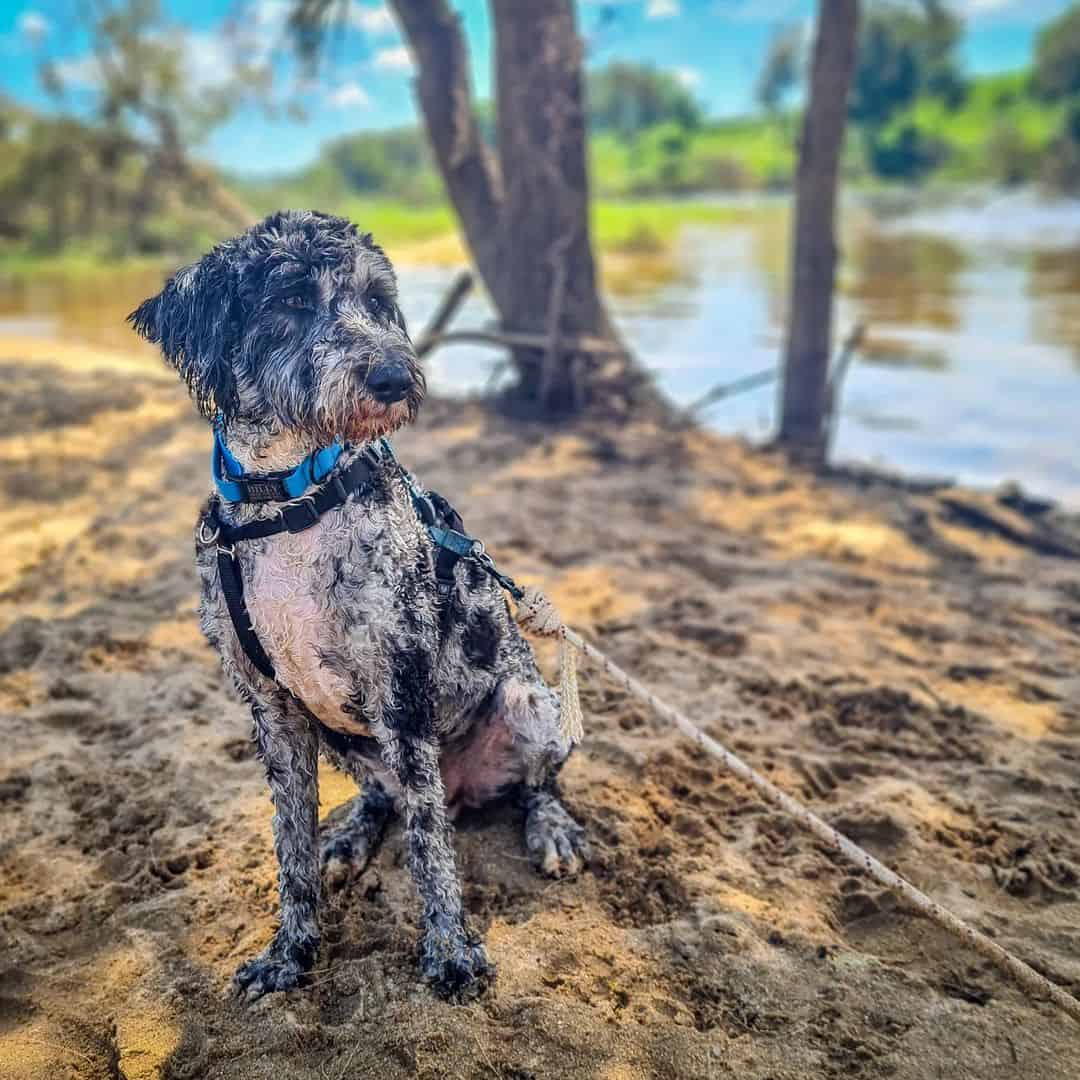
[246,522,379,734]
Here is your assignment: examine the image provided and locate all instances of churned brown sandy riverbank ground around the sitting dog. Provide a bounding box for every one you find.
[0,349,1080,1080]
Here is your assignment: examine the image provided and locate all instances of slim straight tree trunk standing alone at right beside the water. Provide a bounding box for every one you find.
[778,0,859,465]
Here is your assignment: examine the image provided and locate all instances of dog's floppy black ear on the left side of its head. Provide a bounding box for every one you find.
[127,251,239,418]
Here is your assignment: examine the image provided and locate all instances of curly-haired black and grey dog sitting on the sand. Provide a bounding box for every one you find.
[130,212,583,999]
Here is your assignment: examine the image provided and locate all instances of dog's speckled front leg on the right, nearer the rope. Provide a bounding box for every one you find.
[386,727,495,999]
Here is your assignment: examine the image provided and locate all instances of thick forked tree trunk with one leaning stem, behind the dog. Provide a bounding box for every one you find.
[293,0,657,417]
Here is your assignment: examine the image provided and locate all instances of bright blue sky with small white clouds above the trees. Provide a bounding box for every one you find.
[0,0,1069,174]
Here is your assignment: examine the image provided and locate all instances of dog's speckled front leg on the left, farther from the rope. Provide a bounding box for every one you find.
[233,694,319,1001]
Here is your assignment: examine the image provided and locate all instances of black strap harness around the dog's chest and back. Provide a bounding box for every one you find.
[197,440,509,679]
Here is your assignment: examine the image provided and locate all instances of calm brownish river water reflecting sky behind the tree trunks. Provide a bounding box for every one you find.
[0,199,1080,504]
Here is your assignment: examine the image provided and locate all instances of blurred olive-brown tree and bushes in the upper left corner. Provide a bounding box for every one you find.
[0,0,266,254]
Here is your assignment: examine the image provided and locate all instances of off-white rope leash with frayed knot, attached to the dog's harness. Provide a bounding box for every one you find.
[516,588,1080,1022]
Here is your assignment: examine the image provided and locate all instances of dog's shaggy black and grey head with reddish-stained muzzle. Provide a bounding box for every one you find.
[129,211,424,444]
